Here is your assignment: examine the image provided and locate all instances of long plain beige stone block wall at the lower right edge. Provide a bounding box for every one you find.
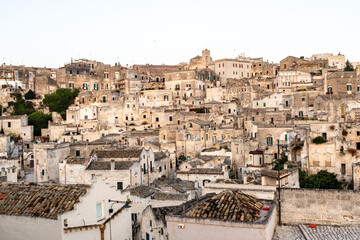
[281,189,360,225]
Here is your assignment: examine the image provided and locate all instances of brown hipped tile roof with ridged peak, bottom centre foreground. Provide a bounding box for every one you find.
[183,190,263,222]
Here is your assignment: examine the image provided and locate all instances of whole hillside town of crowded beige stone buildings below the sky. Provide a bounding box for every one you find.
[0,49,360,240]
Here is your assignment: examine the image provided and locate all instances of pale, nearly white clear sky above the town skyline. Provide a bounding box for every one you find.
[0,0,360,67]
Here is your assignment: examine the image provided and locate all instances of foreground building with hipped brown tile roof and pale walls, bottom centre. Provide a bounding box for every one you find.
[166,190,276,240]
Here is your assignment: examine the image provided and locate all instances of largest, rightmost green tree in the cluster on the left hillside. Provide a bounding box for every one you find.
[43,88,79,119]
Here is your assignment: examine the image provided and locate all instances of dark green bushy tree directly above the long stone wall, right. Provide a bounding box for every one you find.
[299,170,342,189]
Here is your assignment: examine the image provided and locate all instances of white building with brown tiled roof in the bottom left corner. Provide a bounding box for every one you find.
[0,182,132,240]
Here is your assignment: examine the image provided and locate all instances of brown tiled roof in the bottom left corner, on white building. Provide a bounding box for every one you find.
[0,184,89,219]
